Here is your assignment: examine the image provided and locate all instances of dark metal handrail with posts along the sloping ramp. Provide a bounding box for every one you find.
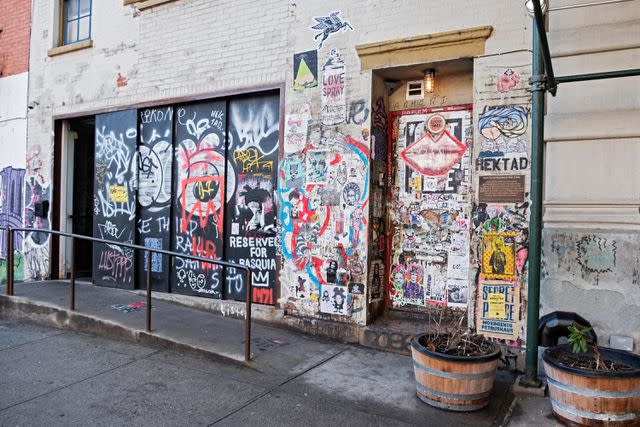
[0,226,253,362]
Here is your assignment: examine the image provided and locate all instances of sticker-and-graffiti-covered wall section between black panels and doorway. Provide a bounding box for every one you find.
[277,15,372,324]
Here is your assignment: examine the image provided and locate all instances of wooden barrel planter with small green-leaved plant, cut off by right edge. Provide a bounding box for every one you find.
[542,345,640,426]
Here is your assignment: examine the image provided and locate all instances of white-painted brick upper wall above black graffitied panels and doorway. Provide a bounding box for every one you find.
[28,0,531,323]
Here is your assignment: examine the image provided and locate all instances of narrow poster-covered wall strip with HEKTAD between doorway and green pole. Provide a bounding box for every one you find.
[470,61,531,347]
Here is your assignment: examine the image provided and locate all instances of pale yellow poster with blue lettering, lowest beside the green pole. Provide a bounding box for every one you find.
[476,280,520,340]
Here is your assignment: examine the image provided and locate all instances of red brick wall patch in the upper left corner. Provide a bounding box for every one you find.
[0,0,31,78]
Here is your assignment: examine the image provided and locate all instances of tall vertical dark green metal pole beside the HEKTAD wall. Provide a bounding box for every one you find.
[521,14,546,387]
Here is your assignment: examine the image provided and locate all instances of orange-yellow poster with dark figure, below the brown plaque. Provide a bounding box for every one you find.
[482,232,516,279]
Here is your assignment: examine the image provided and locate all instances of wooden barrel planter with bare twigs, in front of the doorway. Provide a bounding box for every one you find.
[411,334,500,411]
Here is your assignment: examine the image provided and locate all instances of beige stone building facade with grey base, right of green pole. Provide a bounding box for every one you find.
[541,1,640,352]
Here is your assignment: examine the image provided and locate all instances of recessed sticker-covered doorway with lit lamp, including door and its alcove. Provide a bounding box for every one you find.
[370,58,473,317]
